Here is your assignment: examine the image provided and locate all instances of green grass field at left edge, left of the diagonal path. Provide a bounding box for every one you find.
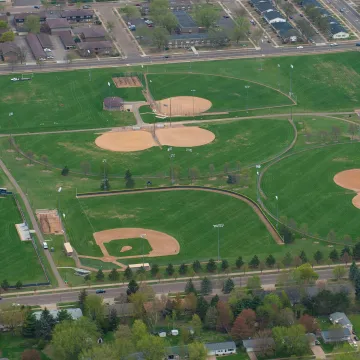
[0,196,46,285]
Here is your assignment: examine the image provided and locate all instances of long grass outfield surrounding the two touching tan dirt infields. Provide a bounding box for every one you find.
[15,118,294,177]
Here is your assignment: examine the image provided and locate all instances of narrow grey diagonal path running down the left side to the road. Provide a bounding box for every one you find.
[0,159,66,288]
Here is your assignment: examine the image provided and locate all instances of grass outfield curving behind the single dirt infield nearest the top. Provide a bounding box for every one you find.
[147,73,292,113]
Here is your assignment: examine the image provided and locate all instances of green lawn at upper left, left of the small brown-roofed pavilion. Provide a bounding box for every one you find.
[0,69,140,133]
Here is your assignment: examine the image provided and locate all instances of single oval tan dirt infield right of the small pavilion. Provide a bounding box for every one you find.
[155,96,212,116]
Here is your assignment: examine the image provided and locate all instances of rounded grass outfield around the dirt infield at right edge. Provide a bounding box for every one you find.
[261,142,360,243]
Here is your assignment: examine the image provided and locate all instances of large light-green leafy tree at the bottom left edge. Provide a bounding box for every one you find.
[51,318,100,360]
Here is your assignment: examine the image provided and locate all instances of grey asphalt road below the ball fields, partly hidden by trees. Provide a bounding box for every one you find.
[1,268,338,305]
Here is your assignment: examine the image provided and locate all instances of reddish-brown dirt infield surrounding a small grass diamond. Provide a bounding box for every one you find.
[93,228,180,261]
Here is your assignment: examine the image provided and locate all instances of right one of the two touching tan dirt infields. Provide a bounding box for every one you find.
[156,126,215,147]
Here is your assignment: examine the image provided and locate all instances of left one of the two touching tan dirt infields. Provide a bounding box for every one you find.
[95,130,157,152]
